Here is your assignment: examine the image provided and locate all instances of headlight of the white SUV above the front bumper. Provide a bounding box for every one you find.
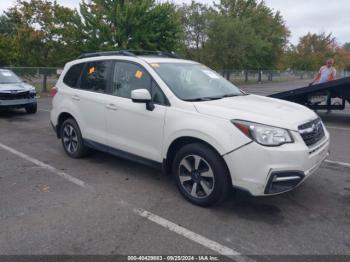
[231,120,294,146]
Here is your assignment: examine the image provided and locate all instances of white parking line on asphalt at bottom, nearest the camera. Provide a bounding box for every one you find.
[133,209,255,262]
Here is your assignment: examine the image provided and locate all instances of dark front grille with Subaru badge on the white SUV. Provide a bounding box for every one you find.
[298,118,325,146]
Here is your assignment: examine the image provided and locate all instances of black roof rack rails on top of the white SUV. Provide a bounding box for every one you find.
[78,50,180,59]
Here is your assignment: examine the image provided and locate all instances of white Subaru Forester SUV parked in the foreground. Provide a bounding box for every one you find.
[51,51,329,206]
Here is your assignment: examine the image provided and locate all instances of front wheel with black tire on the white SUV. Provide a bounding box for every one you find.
[172,143,232,206]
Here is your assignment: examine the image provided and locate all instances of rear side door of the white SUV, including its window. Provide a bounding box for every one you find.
[71,61,112,144]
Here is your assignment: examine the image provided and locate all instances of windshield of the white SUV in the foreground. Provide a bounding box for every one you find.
[151,63,243,101]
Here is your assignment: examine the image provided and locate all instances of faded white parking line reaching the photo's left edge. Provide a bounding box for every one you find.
[0,143,92,189]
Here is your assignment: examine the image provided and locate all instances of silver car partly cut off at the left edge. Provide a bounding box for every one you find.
[0,69,37,114]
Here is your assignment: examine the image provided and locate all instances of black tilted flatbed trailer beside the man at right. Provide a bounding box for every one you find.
[270,77,350,110]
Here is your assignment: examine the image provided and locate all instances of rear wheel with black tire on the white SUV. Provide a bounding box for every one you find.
[60,118,88,158]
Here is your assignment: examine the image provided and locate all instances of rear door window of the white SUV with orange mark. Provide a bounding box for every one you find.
[79,61,111,93]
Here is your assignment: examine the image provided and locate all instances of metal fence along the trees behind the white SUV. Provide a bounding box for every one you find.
[6,67,350,92]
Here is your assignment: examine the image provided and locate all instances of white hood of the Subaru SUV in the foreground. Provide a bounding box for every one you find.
[193,95,317,130]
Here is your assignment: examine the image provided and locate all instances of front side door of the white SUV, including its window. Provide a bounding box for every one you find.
[106,61,167,162]
